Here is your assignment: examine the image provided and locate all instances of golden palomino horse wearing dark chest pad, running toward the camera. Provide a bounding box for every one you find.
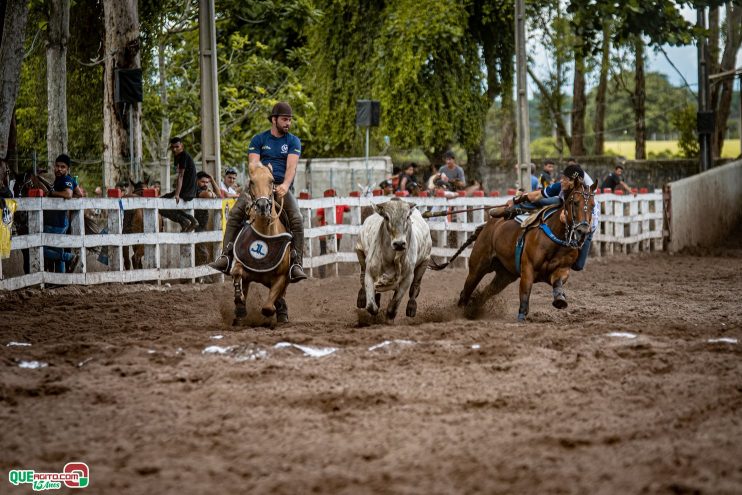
[230,165,291,325]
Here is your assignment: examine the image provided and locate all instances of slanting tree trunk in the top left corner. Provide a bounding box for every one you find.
[0,0,28,159]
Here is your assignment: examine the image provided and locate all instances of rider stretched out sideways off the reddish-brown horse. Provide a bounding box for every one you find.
[489,165,600,271]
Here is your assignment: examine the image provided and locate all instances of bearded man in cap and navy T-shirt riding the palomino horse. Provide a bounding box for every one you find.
[209,102,307,286]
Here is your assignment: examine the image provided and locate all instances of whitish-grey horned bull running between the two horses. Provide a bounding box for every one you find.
[356,198,433,320]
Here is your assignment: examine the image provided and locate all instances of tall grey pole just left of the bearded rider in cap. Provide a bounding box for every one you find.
[198,0,222,180]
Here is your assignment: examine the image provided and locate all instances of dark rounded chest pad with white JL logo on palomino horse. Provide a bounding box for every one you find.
[234,224,292,272]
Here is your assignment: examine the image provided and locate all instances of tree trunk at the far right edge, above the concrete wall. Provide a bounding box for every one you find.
[711,2,742,158]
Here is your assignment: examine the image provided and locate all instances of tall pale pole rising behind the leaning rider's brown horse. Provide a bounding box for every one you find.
[515,0,531,192]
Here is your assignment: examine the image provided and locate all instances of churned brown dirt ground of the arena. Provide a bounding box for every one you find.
[0,246,742,495]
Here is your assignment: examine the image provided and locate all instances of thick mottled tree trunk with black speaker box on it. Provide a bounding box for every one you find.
[103,0,142,187]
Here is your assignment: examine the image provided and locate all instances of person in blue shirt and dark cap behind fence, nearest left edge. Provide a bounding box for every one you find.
[44,153,79,273]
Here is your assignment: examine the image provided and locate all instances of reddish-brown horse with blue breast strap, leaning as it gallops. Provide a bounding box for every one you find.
[431,179,596,321]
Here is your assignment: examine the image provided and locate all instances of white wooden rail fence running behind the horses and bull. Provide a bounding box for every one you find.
[0,192,663,290]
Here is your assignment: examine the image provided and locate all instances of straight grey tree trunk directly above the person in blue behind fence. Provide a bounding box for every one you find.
[46,0,70,165]
